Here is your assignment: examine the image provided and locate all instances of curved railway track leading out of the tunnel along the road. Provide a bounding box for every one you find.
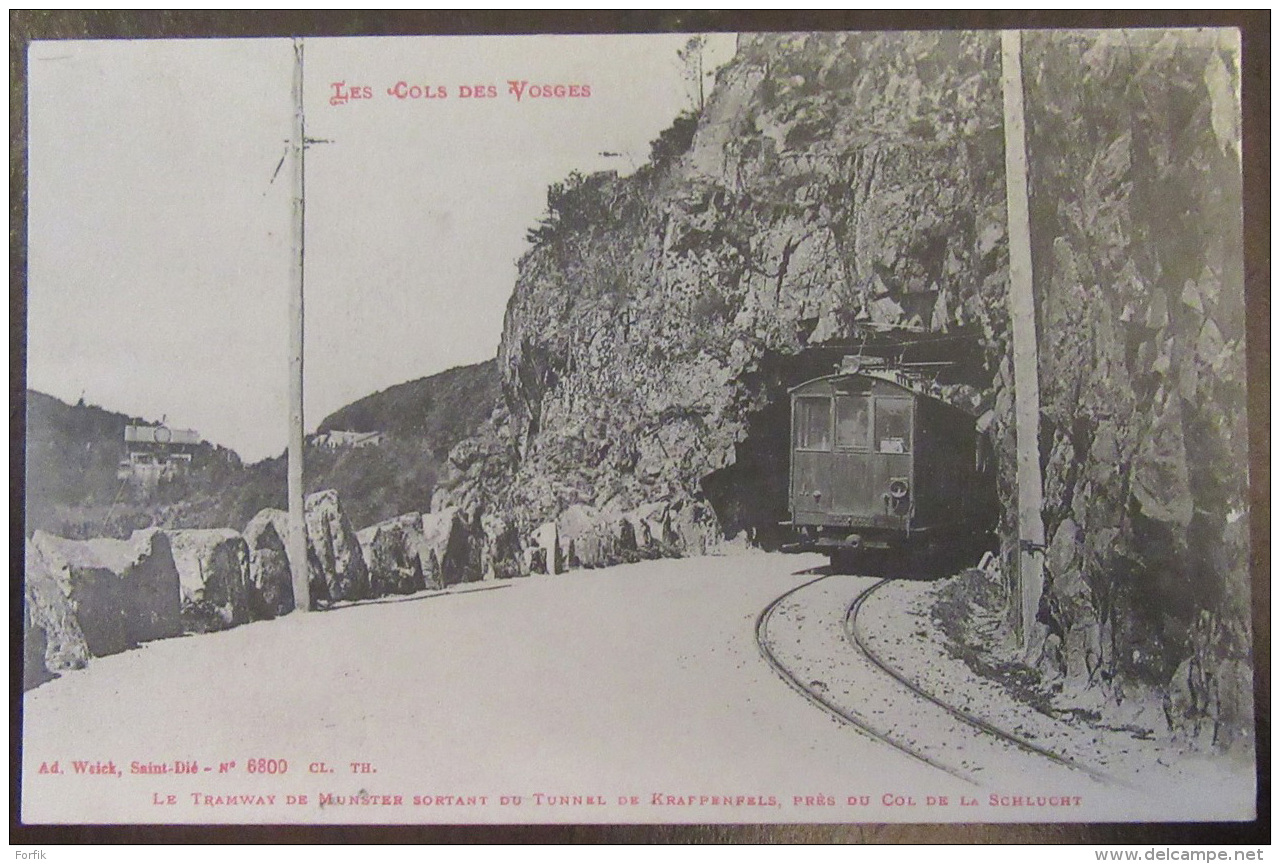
[755,575,1125,786]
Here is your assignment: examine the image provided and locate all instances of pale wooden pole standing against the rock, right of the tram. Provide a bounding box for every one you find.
[1000,31,1044,650]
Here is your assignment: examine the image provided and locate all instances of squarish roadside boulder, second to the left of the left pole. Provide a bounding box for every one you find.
[168,529,250,632]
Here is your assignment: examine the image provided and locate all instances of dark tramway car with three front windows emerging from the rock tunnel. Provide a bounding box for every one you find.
[783,356,996,567]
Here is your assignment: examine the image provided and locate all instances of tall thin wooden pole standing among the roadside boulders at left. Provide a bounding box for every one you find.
[287,38,311,612]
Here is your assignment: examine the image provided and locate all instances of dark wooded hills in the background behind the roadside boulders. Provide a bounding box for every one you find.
[26,361,498,538]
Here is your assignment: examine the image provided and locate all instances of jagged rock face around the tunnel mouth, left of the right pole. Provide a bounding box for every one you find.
[471,33,1005,543]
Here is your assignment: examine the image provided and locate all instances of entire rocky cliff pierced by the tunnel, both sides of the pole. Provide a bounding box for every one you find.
[434,32,1251,744]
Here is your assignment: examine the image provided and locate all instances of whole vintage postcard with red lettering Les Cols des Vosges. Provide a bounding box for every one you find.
[20,28,1257,824]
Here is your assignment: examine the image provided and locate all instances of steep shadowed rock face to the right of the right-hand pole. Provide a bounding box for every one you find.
[1025,32,1253,745]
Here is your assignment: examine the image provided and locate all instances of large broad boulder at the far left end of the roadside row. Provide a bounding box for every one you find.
[29,529,182,669]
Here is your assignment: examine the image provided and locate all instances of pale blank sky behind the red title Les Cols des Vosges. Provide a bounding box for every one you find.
[27,35,735,461]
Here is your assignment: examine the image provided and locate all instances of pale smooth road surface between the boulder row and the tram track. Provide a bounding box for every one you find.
[23,553,972,822]
